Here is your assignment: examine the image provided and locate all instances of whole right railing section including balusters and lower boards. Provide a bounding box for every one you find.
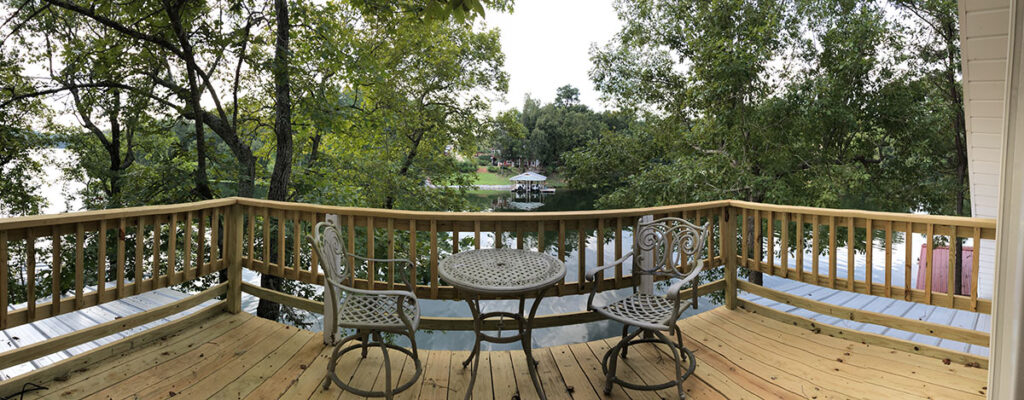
[722,201,995,367]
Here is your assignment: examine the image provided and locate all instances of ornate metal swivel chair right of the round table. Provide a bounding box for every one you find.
[587,218,709,399]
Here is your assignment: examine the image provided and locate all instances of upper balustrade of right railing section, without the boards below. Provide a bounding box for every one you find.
[733,202,995,314]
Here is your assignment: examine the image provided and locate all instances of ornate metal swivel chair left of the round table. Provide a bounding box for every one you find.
[310,222,423,399]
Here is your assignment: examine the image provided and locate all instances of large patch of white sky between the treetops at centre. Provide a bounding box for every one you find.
[485,0,622,109]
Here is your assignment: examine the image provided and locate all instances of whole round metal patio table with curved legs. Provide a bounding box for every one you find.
[437,249,565,400]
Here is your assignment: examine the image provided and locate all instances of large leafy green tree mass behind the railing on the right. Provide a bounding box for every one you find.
[566,0,958,288]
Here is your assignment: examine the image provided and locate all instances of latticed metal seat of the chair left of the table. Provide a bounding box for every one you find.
[338,294,420,330]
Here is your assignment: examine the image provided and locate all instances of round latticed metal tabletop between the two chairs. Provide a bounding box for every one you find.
[437,249,565,295]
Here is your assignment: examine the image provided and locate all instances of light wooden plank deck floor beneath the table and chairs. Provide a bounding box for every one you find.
[0,308,987,399]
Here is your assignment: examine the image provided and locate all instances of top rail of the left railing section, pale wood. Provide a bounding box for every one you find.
[0,197,238,230]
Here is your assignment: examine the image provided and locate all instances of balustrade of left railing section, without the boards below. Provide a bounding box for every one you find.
[0,198,236,329]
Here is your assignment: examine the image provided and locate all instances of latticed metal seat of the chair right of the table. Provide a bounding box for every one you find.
[594,293,689,330]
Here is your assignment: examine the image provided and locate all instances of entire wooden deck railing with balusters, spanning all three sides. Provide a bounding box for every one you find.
[0,197,995,366]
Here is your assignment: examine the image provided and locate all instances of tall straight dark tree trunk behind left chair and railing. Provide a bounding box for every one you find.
[256,0,292,320]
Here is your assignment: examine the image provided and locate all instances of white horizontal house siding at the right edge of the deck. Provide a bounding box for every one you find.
[959,0,1011,299]
